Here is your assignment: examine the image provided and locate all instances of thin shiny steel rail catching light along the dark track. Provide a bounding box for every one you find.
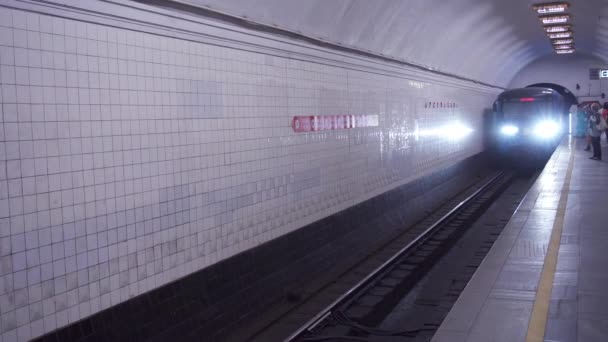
[284,171,505,342]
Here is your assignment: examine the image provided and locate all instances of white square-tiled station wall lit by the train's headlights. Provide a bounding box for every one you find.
[0,3,492,342]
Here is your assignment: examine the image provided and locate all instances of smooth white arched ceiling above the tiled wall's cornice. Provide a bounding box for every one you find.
[163,0,608,86]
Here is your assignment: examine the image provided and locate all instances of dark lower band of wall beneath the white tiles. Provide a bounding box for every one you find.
[30,155,490,342]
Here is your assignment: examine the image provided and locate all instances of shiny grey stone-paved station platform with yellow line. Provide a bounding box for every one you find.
[432,137,608,342]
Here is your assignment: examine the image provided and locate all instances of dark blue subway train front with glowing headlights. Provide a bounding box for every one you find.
[490,87,567,156]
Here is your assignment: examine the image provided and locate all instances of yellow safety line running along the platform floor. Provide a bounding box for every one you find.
[526,140,576,342]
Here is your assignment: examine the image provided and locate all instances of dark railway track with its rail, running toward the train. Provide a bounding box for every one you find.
[285,171,516,342]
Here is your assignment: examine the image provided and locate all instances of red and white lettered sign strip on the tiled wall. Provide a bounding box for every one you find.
[291,115,378,132]
